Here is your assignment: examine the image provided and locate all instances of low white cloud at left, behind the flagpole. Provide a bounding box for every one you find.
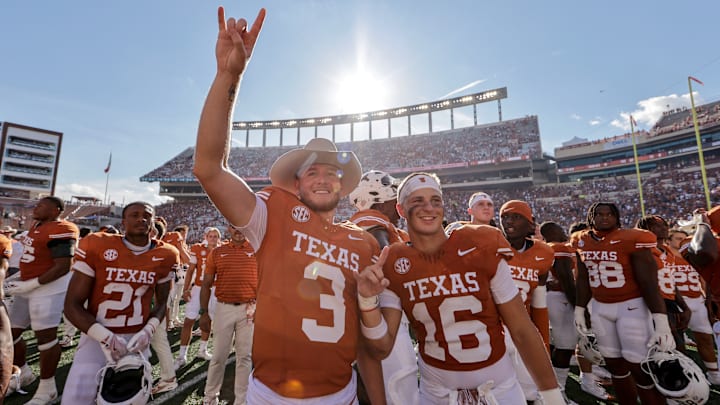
[55,176,170,205]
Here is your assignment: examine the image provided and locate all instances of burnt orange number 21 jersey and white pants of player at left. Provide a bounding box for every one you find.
[63,232,181,404]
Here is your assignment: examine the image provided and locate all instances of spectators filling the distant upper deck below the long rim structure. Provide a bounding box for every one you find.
[141,116,542,181]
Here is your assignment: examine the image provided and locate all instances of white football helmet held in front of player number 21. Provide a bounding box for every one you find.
[96,353,152,405]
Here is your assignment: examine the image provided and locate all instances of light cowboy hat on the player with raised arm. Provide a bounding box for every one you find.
[270,138,362,197]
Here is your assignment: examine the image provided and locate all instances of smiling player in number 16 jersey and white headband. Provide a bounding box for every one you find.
[358,173,565,404]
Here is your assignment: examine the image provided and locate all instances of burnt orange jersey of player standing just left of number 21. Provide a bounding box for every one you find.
[20,221,80,280]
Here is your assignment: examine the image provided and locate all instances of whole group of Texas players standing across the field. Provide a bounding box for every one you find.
[0,8,720,405]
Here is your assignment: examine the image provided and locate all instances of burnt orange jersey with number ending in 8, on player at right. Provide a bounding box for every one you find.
[571,229,657,303]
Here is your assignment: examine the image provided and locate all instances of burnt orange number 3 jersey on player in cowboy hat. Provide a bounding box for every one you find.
[252,187,380,398]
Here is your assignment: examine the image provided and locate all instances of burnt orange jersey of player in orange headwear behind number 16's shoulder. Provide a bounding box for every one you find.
[508,240,555,309]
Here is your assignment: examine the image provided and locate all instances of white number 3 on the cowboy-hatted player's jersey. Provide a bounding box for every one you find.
[302,262,345,343]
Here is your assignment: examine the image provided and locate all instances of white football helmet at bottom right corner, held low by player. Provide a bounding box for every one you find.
[640,345,710,405]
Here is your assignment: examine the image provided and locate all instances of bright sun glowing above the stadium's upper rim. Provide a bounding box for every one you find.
[335,70,387,114]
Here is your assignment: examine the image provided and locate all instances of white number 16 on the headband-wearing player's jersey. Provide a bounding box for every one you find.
[412,295,492,363]
